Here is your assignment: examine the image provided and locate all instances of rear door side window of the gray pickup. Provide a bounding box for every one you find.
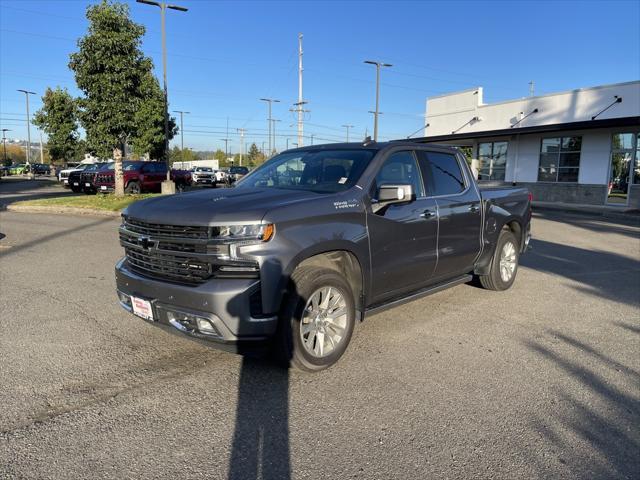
[419,151,465,196]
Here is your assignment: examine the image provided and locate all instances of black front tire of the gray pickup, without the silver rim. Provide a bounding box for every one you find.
[274,267,356,372]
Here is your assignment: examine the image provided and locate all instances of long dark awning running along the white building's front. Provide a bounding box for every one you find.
[411,117,640,143]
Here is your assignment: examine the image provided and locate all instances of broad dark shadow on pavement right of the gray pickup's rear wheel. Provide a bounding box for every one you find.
[520,239,640,306]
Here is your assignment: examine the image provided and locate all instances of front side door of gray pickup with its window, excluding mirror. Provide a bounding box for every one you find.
[367,150,438,303]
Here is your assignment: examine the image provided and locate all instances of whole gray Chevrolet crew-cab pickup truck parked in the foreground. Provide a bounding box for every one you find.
[115,141,531,371]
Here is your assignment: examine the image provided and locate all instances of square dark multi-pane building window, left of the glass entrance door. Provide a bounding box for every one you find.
[538,137,582,182]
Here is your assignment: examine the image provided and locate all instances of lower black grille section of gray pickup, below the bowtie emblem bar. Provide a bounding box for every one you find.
[125,247,212,285]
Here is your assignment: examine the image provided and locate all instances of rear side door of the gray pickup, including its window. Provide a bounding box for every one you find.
[417,150,482,280]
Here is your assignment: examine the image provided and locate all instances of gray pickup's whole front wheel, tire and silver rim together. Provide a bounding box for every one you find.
[276,267,356,372]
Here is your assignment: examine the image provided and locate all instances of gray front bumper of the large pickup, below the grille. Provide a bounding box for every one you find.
[115,259,278,351]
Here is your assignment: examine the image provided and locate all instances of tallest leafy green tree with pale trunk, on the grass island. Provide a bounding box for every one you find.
[69,0,175,195]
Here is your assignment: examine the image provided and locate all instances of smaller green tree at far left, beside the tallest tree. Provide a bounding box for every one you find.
[33,87,81,162]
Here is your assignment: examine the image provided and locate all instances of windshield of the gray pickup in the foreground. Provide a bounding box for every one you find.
[237,149,376,193]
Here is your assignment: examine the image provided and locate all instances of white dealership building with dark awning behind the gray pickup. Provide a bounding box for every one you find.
[418,81,640,208]
